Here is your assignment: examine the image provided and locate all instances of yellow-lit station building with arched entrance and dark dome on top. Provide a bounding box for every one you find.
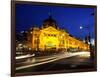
[32,16,89,51]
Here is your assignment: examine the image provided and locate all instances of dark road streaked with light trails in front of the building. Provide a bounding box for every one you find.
[16,52,93,73]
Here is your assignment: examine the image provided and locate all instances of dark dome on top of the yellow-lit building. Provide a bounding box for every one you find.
[43,16,57,28]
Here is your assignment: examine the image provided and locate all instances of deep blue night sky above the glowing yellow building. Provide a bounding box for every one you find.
[15,4,95,39]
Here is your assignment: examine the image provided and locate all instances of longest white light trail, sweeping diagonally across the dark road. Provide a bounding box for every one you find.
[16,51,90,70]
